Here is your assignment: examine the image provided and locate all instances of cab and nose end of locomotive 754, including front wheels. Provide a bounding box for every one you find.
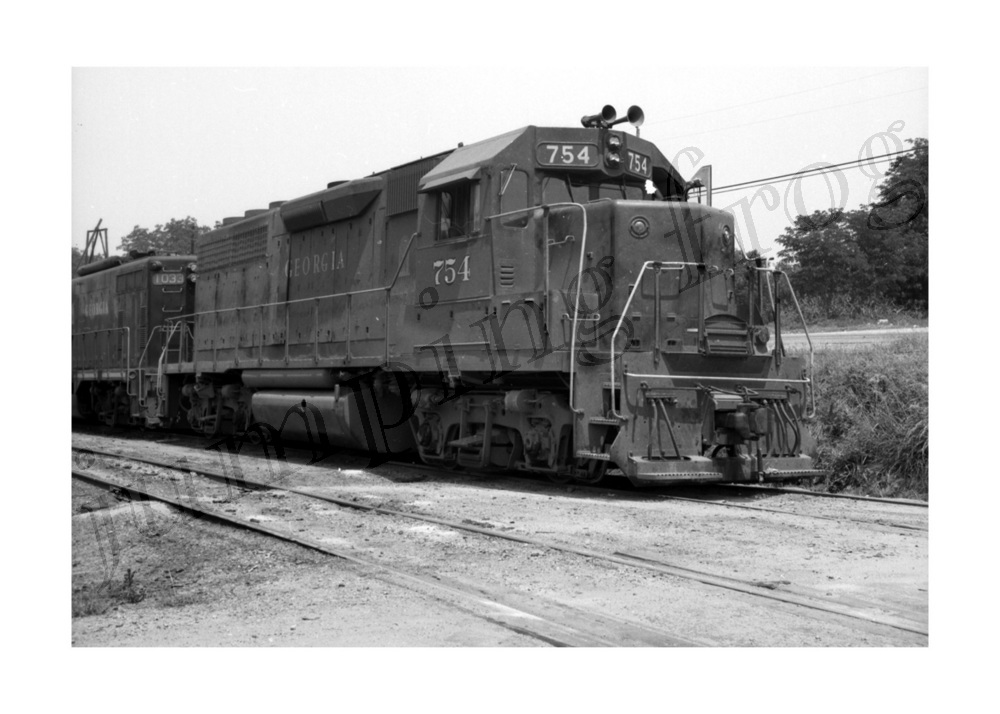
[411,107,820,484]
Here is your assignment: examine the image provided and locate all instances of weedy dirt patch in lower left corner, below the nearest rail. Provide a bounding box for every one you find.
[72,483,536,647]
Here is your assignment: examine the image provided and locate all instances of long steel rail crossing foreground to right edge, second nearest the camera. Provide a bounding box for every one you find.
[73,447,928,636]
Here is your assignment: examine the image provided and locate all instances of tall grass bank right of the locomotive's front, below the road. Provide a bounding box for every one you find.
[813,335,929,499]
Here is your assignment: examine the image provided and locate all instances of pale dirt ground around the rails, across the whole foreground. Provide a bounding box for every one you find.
[72,428,928,647]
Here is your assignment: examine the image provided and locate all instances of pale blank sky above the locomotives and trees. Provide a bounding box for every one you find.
[71,63,929,255]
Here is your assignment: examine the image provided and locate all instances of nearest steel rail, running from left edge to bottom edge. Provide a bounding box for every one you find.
[71,464,697,647]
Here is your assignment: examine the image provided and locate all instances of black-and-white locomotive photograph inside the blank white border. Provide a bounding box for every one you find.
[72,67,930,647]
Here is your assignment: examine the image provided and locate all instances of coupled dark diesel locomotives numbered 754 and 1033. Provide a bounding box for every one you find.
[73,107,820,484]
